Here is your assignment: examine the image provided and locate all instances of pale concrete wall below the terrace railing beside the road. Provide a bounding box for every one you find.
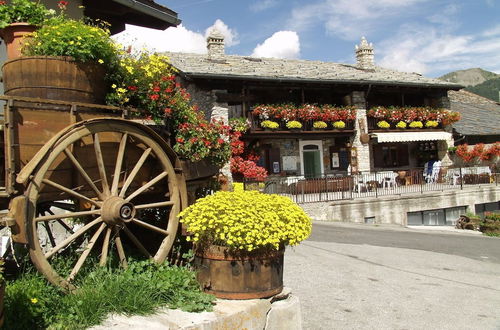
[301,186,500,226]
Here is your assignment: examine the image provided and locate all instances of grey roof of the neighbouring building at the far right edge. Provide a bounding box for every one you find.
[448,90,500,135]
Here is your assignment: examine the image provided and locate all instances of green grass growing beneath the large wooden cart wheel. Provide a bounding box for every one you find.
[4,261,214,329]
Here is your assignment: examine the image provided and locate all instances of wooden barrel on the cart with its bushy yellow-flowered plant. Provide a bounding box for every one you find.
[3,14,118,103]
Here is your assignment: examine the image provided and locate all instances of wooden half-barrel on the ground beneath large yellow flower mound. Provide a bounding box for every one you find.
[194,245,285,299]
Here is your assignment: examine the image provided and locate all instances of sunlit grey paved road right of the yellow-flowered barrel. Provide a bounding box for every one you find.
[284,223,500,330]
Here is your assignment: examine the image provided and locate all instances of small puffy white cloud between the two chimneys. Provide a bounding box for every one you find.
[252,31,300,58]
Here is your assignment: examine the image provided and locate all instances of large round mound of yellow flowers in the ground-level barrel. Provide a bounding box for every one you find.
[179,189,312,251]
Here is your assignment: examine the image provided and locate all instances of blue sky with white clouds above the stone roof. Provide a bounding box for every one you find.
[114,0,500,77]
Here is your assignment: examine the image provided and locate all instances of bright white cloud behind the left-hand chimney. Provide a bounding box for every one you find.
[113,19,239,54]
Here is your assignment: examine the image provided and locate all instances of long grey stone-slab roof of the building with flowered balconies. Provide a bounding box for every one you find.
[165,52,463,89]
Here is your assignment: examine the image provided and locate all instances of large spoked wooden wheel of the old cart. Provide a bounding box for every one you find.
[26,120,181,290]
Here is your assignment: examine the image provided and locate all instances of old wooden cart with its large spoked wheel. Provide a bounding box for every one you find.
[0,96,191,290]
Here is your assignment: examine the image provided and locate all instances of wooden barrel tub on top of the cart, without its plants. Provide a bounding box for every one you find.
[3,56,106,104]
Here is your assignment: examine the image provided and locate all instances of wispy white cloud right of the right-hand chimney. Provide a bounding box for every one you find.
[375,26,500,74]
